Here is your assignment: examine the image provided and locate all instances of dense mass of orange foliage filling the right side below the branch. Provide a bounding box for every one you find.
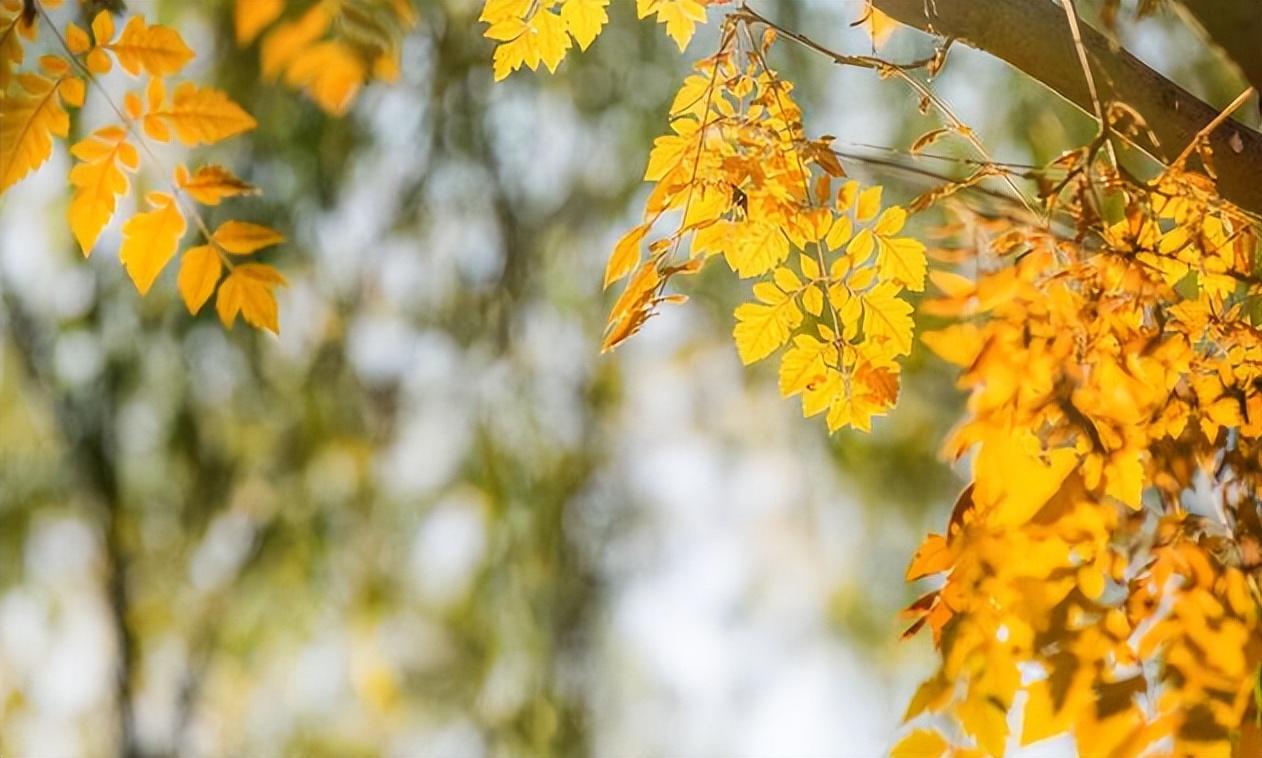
[905,153,1262,755]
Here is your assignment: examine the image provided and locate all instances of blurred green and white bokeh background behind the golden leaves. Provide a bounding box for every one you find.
[0,0,1257,758]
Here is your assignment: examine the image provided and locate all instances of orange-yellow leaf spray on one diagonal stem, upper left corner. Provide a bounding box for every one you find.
[0,0,285,332]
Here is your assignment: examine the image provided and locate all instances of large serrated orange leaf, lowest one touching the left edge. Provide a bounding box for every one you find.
[0,73,71,193]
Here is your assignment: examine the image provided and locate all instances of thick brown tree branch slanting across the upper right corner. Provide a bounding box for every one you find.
[873,0,1262,213]
